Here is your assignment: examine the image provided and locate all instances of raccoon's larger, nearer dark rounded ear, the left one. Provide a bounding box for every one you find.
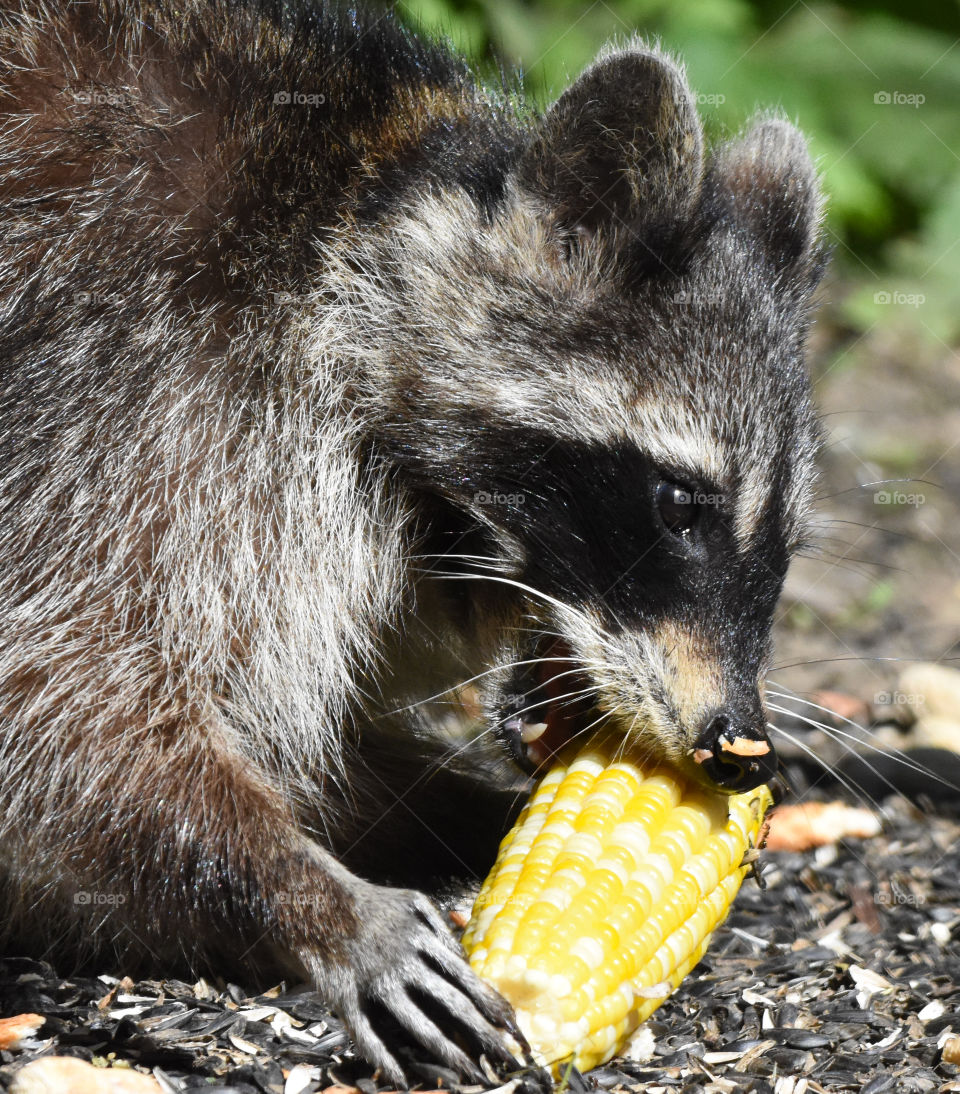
[519,47,703,235]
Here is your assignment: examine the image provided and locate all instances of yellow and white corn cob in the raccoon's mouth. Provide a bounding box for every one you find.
[464,742,771,1074]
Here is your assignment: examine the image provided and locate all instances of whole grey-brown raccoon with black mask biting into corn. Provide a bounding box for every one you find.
[0,0,822,1085]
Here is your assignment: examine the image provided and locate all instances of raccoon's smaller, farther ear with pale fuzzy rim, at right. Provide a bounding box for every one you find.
[711,119,822,277]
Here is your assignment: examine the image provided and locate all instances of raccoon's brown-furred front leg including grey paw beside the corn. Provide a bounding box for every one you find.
[24,724,516,1086]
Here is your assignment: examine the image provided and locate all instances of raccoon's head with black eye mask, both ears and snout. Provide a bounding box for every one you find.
[367,46,821,791]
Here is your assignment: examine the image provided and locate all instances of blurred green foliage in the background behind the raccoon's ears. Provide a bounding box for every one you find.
[398,0,960,344]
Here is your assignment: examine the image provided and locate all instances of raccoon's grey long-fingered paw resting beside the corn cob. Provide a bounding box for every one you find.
[303,883,526,1089]
